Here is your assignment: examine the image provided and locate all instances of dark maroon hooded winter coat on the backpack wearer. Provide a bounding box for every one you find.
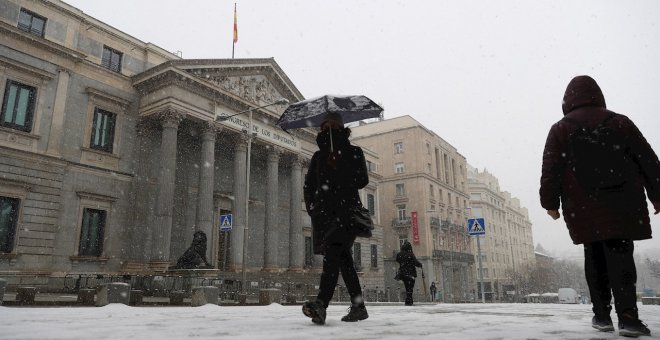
[539,76,660,244]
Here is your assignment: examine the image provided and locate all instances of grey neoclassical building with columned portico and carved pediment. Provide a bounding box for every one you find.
[0,0,383,290]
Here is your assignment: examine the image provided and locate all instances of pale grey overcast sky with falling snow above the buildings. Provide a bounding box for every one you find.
[62,0,660,253]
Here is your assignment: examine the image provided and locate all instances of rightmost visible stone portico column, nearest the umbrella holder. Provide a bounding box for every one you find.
[289,157,305,271]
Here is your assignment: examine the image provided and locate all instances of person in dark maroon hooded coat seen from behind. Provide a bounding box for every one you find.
[539,76,660,337]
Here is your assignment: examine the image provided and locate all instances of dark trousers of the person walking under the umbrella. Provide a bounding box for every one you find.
[317,238,362,308]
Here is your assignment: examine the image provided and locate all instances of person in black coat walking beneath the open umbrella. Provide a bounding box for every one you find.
[303,113,369,324]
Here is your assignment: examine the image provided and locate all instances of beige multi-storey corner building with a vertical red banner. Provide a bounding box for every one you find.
[352,116,476,302]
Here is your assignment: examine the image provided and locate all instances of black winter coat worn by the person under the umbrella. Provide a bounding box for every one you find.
[303,128,369,254]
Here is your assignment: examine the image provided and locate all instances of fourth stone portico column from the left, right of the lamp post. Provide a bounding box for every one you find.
[264,147,281,271]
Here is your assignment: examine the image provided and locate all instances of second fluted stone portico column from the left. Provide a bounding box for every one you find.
[195,122,218,266]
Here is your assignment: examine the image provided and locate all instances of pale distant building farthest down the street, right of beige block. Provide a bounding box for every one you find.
[468,166,536,301]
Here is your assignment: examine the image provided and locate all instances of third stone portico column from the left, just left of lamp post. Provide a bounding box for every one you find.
[228,134,248,271]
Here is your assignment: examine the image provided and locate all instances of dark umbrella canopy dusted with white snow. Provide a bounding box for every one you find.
[276,95,383,130]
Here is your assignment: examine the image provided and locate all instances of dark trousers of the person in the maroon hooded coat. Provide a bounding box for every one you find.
[584,239,637,317]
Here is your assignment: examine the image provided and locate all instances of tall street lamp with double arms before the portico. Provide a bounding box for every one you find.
[215,98,289,298]
